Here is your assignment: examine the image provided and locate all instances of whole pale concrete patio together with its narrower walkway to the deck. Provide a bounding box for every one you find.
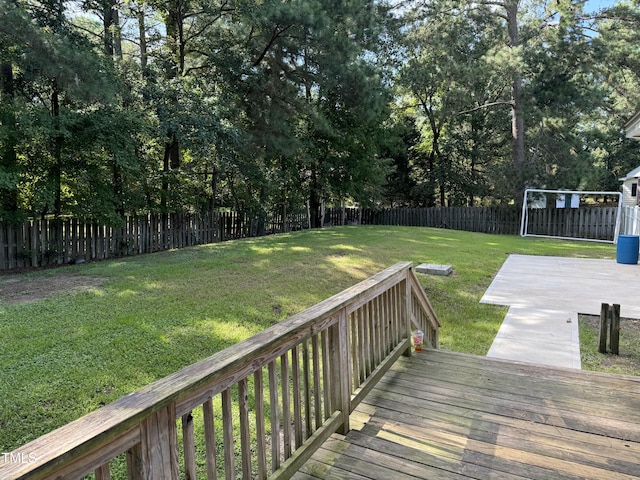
[480,255,640,368]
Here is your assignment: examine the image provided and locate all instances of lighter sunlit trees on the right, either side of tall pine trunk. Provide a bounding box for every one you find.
[388,0,640,205]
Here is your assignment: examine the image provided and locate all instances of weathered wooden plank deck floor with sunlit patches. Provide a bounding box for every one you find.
[293,350,640,480]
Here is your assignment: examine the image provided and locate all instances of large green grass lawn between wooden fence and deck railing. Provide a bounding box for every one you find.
[0,226,615,452]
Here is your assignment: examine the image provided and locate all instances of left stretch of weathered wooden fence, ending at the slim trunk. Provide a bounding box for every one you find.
[0,212,307,270]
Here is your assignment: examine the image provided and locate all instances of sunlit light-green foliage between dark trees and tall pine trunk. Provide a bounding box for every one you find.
[397,1,513,205]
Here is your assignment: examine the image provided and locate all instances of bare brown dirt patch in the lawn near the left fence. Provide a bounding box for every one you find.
[0,272,106,304]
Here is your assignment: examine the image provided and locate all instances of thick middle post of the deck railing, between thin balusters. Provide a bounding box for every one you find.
[329,308,351,435]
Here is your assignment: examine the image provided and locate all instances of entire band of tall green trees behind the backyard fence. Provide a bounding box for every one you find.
[0,0,640,221]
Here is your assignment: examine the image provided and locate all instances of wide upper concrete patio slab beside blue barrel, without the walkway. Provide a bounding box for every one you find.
[480,255,640,318]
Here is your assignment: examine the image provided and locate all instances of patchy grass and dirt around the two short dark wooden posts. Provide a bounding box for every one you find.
[580,315,640,376]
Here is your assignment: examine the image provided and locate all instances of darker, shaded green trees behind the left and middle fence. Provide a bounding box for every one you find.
[0,0,396,223]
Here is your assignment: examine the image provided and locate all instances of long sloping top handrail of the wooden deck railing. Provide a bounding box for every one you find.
[0,262,412,479]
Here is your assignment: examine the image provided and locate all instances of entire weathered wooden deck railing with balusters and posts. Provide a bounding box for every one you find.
[0,262,439,480]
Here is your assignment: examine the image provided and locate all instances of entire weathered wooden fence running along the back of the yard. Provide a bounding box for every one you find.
[0,206,620,270]
